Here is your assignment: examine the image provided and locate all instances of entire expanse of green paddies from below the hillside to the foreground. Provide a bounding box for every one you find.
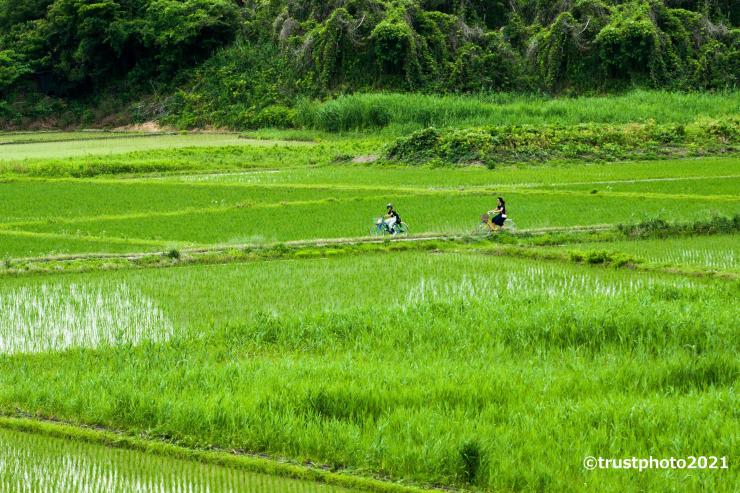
[0,120,740,492]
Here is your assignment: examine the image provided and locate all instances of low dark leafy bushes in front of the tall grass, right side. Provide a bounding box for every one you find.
[385,119,740,168]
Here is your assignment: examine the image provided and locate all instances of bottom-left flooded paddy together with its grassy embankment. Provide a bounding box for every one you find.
[0,418,425,493]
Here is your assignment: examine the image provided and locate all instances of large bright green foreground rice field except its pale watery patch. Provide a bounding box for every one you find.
[0,252,740,491]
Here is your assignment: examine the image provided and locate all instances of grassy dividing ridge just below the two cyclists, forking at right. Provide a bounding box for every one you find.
[0,225,740,281]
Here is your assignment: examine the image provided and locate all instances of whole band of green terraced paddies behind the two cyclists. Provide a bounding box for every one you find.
[0,154,740,257]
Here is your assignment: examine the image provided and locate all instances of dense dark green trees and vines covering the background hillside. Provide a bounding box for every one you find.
[0,0,740,128]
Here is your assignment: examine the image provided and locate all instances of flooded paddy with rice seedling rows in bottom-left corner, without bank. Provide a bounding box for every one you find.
[0,429,358,493]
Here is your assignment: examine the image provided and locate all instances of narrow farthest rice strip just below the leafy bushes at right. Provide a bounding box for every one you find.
[162,157,739,193]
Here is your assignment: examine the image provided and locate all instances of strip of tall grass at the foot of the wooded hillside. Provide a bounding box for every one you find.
[297,90,740,133]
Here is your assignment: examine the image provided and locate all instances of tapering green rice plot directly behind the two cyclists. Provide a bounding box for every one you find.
[18,190,740,248]
